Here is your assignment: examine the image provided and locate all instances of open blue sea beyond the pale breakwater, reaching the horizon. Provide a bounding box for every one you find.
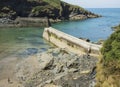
[53,8,120,42]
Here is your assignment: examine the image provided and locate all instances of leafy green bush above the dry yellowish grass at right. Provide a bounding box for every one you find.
[101,30,120,62]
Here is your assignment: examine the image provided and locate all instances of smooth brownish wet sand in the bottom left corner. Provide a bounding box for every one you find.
[0,57,22,87]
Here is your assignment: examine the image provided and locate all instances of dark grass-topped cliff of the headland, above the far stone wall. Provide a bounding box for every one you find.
[0,0,98,20]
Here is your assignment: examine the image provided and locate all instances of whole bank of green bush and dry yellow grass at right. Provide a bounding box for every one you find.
[96,26,120,87]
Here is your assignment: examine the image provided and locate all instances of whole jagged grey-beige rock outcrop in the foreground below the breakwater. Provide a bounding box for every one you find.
[13,48,98,87]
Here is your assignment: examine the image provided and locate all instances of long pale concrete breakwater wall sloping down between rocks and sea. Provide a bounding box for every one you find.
[43,27,102,55]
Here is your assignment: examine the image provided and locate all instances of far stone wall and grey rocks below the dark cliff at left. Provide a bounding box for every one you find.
[0,17,49,28]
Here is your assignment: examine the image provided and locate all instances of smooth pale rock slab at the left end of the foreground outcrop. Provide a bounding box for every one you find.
[15,53,53,82]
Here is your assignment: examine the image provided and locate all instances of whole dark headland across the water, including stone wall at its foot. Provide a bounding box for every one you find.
[0,0,99,27]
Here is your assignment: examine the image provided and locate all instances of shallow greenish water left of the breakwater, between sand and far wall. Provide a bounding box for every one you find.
[0,28,51,59]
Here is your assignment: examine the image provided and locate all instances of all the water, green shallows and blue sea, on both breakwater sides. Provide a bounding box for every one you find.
[0,9,120,59]
